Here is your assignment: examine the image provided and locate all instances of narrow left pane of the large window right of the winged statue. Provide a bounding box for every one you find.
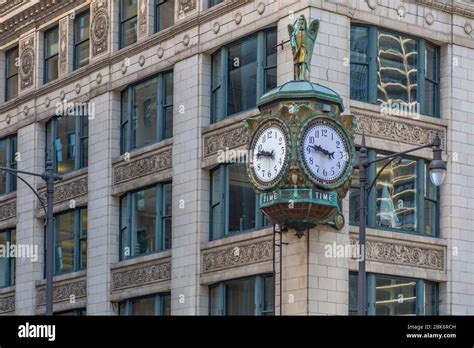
[351,26,369,101]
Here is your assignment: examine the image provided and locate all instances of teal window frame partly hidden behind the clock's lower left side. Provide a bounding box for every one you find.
[209,163,268,241]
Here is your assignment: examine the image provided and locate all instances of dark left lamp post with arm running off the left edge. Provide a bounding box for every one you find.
[0,159,62,315]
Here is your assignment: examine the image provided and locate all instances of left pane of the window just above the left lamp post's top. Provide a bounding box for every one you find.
[54,116,77,174]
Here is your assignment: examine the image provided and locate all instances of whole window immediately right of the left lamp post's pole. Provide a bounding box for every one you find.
[54,208,87,274]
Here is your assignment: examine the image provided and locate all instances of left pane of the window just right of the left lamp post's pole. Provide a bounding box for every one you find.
[55,212,75,273]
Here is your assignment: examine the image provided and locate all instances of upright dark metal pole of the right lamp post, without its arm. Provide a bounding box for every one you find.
[357,134,367,315]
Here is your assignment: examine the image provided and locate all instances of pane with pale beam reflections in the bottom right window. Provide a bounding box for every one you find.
[375,277,416,315]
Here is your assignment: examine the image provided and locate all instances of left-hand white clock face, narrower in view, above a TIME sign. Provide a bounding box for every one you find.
[250,121,288,188]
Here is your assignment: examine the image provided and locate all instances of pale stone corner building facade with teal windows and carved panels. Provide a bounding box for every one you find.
[0,0,474,315]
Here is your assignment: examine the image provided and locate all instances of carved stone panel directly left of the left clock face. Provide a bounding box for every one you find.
[203,124,245,157]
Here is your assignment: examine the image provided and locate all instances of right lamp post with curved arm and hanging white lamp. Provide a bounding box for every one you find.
[357,134,446,315]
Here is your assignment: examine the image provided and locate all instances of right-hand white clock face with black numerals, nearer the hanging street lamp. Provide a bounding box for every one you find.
[301,119,350,187]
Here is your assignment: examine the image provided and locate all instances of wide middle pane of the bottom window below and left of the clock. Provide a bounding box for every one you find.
[225,278,255,315]
